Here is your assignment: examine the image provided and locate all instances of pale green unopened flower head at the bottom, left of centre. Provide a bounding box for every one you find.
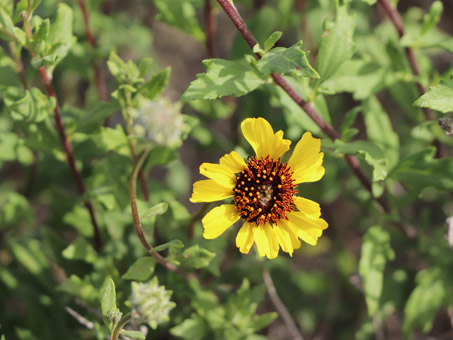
[131,277,176,329]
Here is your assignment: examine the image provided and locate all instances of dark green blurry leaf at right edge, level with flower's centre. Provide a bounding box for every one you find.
[389,147,453,192]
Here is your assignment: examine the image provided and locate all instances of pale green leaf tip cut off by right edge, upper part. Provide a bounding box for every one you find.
[414,81,453,113]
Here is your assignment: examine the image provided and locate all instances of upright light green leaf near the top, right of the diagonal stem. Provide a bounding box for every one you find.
[316,6,355,81]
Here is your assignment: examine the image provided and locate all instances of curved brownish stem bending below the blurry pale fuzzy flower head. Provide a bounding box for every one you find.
[129,148,195,280]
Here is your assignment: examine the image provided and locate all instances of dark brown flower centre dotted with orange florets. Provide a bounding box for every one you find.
[233,156,297,226]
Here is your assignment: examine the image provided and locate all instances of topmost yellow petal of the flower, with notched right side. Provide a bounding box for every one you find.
[241,118,291,159]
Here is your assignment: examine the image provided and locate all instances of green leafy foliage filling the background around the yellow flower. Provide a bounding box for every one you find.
[0,0,453,340]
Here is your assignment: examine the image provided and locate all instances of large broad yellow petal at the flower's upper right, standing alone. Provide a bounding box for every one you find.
[288,132,325,184]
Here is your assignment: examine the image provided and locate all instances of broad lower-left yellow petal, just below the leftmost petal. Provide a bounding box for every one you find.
[201,204,240,240]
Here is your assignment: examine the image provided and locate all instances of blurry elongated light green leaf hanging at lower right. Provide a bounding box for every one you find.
[359,226,395,315]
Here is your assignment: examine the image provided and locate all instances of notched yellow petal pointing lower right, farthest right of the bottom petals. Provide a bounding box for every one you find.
[286,211,328,246]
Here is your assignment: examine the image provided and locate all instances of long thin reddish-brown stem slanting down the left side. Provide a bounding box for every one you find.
[38,66,102,252]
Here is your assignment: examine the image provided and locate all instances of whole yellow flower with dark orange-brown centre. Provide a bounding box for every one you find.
[190,118,327,259]
